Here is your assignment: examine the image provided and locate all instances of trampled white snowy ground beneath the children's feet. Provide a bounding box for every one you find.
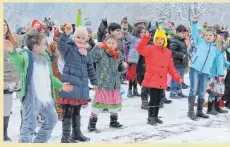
[6,75,230,143]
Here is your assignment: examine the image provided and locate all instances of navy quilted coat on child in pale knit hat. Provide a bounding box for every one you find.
[58,33,98,100]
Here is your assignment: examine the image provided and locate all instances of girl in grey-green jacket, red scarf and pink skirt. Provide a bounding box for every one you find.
[88,34,127,132]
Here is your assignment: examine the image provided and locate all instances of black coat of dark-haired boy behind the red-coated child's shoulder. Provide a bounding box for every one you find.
[169,35,188,68]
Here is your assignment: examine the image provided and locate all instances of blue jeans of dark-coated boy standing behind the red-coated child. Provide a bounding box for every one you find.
[170,68,186,96]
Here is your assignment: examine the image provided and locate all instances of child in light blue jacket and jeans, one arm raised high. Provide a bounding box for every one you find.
[188,16,224,120]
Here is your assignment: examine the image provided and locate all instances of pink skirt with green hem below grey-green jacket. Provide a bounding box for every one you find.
[92,89,122,109]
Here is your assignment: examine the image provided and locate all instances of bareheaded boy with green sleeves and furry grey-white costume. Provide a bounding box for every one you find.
[4,28,72,143]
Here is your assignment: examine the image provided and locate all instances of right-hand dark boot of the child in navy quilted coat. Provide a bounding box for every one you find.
[72,115,90,142]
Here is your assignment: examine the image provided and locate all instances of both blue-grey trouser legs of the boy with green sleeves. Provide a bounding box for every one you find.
[19,96,58,143]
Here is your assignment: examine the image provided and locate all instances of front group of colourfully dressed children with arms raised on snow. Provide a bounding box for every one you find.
[4,12,230,143]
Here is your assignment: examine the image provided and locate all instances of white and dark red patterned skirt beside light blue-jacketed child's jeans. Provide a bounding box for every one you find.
[206,77,225,96]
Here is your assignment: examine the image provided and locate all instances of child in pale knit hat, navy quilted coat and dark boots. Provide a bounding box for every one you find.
[58,23,98,143]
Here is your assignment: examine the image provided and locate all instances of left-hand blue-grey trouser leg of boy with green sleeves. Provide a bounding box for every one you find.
[19,97,37,143]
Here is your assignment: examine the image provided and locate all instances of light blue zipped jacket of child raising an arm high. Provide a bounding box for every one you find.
[190,23,222,75]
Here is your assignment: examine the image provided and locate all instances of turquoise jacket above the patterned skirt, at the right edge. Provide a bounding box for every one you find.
[209,52,230,78]
